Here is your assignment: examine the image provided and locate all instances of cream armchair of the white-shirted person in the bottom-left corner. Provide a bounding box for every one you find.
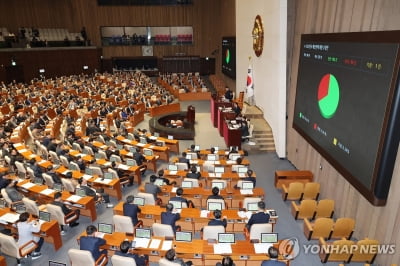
[0,233,38,264]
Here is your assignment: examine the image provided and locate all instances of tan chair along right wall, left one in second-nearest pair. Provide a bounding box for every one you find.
[303,218,333,240]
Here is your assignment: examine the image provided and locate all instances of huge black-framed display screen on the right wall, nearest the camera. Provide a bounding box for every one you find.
[293,32,399,205]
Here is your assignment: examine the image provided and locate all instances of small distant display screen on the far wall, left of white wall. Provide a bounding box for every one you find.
[222,37,236,79]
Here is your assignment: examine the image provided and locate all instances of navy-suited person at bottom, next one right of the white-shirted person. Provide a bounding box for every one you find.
[79,225,107,261]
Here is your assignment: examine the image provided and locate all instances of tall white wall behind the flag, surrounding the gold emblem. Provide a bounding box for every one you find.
[236,0,287,158]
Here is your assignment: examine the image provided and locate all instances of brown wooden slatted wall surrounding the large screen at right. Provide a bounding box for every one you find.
[287,0,400,265]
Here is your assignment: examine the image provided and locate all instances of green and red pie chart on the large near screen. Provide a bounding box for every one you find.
[318,74,340,119]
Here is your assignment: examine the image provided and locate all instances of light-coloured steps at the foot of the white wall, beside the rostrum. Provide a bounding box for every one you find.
[242,103,275,153]
